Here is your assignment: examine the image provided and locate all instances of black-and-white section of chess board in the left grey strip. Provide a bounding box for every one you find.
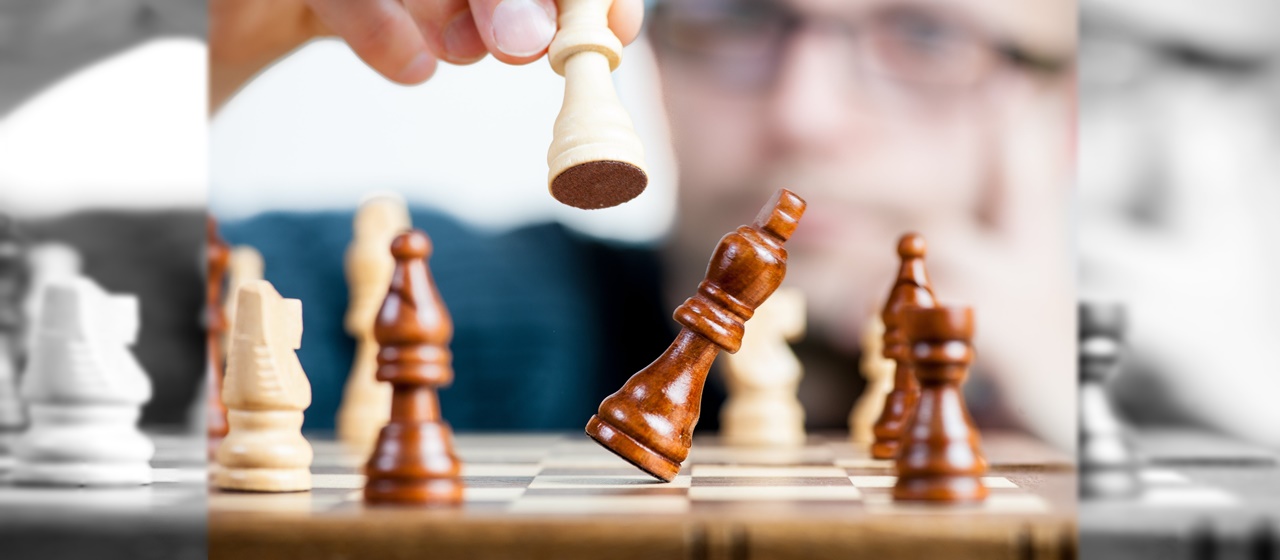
[0,433,207,560]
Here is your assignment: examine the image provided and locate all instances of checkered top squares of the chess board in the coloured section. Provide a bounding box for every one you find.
[285,435,1050,515]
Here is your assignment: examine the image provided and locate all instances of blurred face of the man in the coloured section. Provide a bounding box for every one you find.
[649,0,1074,348]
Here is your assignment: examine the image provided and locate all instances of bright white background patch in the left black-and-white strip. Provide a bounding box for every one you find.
[0,40,209,216]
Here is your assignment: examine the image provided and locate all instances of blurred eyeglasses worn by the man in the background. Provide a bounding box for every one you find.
[650,0,1070,91]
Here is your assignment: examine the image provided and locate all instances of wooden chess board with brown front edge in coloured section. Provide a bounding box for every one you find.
[209,433,1075,559]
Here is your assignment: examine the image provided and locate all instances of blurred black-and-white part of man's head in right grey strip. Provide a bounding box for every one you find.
[1079,0,1280,432]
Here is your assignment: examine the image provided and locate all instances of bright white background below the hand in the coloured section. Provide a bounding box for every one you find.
[210,40,675,240]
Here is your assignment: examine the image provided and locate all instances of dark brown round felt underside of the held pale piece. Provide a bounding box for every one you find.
[550,161,649,210]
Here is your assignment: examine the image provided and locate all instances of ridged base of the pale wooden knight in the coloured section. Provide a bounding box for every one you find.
[212,409,312,492]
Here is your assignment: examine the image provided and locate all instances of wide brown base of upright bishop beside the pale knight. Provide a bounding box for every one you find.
[365,422,463,505]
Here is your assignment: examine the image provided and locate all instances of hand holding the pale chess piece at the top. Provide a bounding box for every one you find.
[209,0,644,107]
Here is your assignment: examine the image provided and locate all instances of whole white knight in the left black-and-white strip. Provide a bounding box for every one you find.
[12,277,155,486]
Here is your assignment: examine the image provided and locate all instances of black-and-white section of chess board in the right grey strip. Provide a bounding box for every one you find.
[1080,428,1280,560]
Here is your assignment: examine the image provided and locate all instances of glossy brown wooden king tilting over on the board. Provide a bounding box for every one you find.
[586,189,805,482]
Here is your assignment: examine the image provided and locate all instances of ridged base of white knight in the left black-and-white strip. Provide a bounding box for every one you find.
[9,404,155,486]
